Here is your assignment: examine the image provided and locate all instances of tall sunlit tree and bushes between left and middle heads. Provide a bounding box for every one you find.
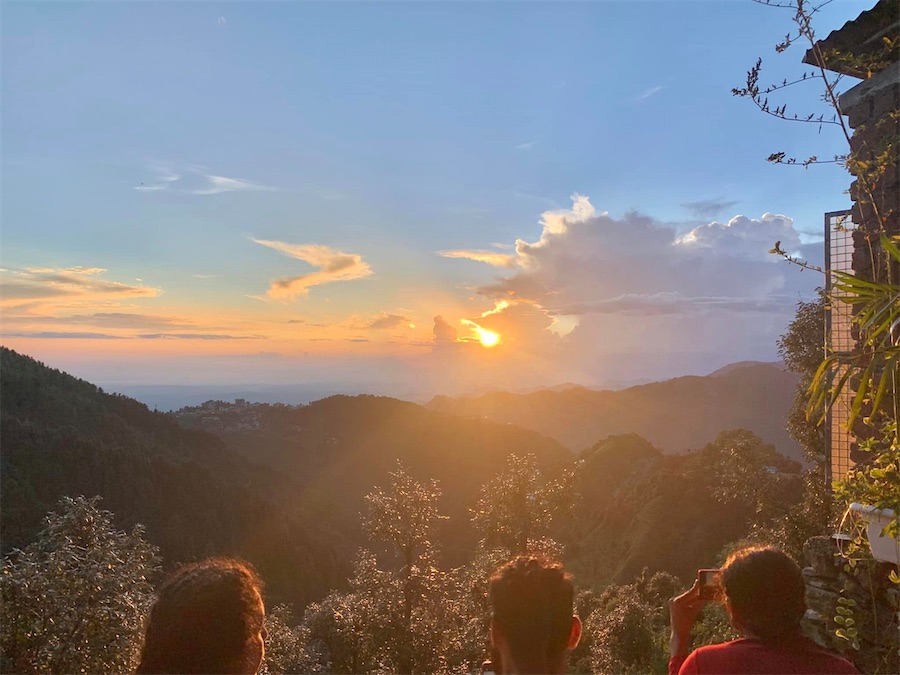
[303,466,450,673]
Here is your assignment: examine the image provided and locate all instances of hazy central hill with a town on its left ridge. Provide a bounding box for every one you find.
[176,396,573,565]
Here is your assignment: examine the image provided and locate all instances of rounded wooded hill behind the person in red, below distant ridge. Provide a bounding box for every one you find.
[564,430,802,583]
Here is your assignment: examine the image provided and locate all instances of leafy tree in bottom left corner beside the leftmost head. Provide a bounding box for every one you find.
[0,497,159,673]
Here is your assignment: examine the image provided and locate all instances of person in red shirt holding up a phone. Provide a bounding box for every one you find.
[669,547,858,675]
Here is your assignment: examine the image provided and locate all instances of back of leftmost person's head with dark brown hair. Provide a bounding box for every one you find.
[137,558,265,675]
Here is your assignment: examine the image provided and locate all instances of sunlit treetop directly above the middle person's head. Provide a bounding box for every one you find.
[472,455,575,554]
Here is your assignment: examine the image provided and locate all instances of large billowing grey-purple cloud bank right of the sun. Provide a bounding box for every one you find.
[435,195,821,386]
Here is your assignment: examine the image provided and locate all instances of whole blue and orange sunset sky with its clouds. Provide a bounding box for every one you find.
[0,0,872,394]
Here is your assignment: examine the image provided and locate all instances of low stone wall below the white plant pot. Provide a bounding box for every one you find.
[803,537,900,674]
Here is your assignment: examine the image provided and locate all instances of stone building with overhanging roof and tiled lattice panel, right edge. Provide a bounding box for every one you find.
[803,0,900,481]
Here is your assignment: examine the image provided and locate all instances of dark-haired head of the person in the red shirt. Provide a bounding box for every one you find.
[722,546,806,640]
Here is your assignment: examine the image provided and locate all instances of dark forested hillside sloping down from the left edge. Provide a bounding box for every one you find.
[0,349,353,603]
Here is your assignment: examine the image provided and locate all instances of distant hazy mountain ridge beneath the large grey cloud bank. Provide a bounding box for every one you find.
[427,362,803,460]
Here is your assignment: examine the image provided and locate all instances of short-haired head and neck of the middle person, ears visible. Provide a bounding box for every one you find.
[490,556,581,674]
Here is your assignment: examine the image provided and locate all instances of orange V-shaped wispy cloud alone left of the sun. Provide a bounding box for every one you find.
[251,239,373,300]
